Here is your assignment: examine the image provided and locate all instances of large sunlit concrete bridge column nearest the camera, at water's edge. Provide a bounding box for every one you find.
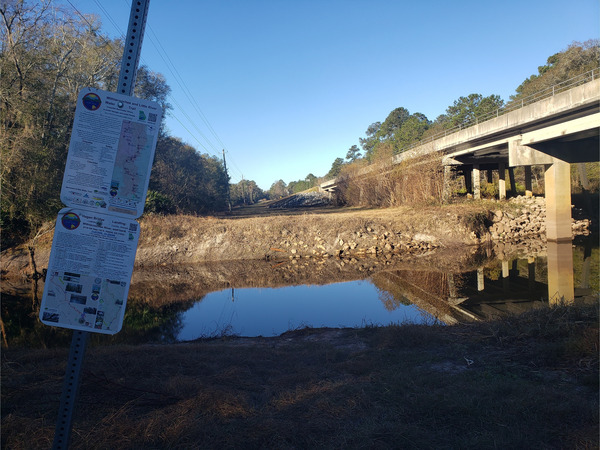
[544,159,573,242]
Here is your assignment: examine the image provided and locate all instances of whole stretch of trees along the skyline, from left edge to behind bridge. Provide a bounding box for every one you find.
[0,0,600,248]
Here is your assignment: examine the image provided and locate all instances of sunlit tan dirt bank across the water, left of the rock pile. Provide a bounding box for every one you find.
[2,204,490,277]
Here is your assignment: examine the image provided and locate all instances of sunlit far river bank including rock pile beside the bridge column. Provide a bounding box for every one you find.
[2,199,589,278]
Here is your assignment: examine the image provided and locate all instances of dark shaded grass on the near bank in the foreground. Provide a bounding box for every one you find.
[2,305,598,449]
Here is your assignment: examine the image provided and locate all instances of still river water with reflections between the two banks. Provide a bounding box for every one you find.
[2,236,600,347]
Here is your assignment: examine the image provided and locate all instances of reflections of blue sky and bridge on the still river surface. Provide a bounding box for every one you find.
[172,242,598,340]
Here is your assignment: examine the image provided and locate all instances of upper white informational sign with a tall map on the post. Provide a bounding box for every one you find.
[60,88,162,218]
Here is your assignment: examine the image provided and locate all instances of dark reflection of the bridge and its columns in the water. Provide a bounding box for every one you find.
[372,242,598,325]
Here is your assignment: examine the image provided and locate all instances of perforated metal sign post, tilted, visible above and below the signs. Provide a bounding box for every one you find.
[48,0,150,449]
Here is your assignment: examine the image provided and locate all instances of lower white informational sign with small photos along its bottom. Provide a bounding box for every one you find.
[40,208,140,334]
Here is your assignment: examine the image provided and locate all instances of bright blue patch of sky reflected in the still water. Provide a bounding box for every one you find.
[177,280,435,341]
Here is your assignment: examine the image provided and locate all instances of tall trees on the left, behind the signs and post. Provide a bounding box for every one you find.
[0,0,229,248]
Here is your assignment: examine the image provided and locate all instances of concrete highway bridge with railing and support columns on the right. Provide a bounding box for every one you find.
[321,69,600,246]
